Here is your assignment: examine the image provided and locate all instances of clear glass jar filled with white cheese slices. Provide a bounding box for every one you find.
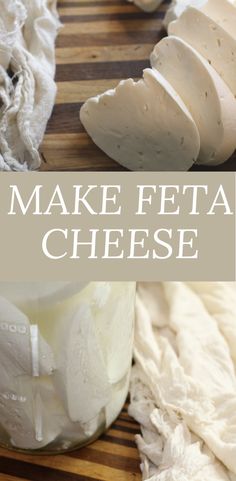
[0,282,135,454]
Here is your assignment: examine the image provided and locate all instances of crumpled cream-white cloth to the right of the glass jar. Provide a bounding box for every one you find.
[129,282,236,481]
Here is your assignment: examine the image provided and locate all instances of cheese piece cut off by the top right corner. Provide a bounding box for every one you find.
[201,0,236,39]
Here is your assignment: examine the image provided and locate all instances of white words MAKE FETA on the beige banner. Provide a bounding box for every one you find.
[8,184,233,216]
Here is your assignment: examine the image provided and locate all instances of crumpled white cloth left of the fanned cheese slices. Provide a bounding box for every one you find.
[0,0,60,171]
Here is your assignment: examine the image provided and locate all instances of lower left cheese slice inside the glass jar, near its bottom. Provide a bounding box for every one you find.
[0,370,60,449]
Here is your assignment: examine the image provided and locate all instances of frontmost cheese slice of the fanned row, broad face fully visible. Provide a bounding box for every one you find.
[80,69,200,171]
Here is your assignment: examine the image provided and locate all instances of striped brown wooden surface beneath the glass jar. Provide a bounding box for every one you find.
[0,404,141,481]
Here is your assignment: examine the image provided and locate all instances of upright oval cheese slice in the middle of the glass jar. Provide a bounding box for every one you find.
[53,302,110,423]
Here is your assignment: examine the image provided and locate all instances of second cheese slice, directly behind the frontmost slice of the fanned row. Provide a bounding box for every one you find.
[151,35,236,165]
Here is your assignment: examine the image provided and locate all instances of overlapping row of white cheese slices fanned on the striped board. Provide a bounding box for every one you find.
[80,0,236,171]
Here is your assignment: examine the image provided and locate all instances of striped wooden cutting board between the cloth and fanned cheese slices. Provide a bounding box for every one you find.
[41,0,236,171]
